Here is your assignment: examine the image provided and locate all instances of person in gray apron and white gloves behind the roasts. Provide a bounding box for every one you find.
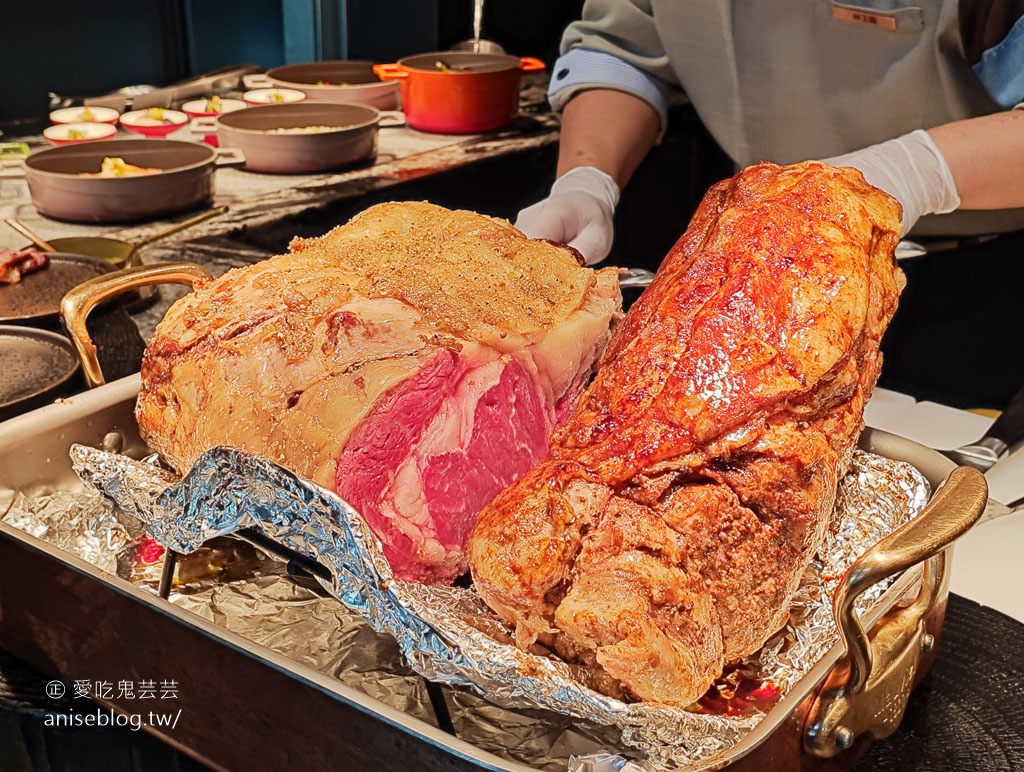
[516,0,1024,408]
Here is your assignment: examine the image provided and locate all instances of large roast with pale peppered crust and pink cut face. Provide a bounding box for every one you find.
[136,203,621,583]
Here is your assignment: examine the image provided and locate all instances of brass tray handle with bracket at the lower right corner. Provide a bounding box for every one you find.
[804,467,988,759]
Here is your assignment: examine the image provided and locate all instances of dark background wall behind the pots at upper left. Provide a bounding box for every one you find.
[0,0,583,121]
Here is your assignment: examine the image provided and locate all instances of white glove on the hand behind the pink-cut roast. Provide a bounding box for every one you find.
[515,166,618,265]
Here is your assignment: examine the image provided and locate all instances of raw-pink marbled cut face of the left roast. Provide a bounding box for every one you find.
[335,351,554,583]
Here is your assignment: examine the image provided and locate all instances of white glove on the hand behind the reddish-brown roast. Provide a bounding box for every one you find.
[823,129,959,235]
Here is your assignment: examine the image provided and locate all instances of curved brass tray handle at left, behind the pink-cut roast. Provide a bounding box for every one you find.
[60,263,213,389]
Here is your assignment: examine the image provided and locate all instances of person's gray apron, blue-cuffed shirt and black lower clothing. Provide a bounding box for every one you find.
[549,0,1024,408]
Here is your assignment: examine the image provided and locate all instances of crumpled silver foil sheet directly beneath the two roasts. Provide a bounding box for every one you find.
[72,445,930,772]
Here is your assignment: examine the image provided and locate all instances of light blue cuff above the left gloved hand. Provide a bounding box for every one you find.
[548,48,672,132]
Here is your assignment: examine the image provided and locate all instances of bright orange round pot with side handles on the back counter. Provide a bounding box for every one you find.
[374,51,544,134]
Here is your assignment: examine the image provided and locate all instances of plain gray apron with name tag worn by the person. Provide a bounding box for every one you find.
[651,0,1024,235]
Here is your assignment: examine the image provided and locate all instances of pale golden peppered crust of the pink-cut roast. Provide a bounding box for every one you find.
[136,202,621,488]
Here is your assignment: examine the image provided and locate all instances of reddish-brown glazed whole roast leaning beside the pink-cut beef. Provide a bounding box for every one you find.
[469,162,903,705]
